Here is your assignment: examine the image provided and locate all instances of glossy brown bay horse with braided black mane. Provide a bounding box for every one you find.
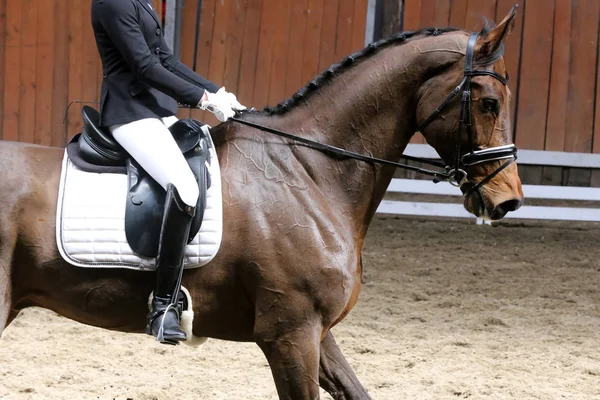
[0,9,523,399]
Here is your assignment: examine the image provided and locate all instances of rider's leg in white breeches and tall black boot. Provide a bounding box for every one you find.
[110,118,198,344]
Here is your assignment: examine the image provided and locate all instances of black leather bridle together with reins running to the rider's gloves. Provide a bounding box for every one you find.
[229,33,517,196]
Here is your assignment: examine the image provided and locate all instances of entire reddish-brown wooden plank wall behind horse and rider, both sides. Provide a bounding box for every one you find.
[0,0,600,185]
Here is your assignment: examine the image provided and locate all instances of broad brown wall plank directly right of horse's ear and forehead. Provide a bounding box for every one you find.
[516,0,554,150]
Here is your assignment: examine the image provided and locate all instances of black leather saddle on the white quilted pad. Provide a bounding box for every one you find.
[67,106,211,257]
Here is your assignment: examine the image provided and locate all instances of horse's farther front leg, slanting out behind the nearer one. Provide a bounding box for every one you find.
[319,332,371,400]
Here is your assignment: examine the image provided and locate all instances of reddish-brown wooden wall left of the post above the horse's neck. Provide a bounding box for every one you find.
[0,0,367,146]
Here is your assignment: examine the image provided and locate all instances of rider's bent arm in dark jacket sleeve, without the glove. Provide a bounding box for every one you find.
[97,0,216,107]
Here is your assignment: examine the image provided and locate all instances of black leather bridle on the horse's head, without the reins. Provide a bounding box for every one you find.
[419,33,517,196]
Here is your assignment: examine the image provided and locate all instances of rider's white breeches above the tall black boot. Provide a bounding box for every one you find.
[109,116,199,207]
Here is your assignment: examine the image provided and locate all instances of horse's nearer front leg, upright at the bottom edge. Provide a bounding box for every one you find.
[254,321,321,400]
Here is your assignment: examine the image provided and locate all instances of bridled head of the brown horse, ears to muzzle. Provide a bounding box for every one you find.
[416,7,523,220]
